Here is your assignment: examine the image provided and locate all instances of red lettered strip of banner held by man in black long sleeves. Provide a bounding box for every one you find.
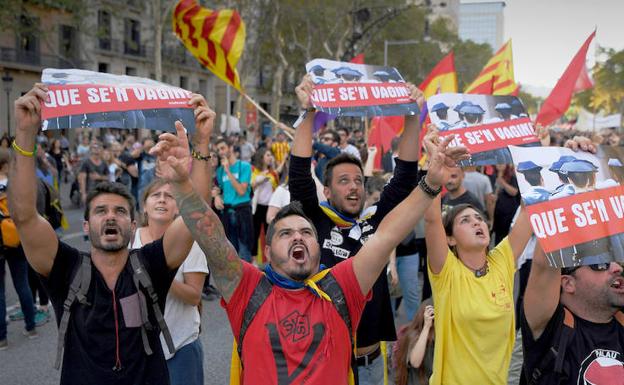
[312,83,413,108]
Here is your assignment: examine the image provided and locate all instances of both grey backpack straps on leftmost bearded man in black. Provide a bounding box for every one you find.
[54,249,175,370]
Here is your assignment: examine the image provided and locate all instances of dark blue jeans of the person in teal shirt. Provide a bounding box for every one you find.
[223,204,257,262]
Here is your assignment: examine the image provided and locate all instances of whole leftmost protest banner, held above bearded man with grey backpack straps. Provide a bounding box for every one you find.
[41,68,195,132]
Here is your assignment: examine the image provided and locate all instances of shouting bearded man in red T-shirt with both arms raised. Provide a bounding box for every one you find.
[147,116,468,385]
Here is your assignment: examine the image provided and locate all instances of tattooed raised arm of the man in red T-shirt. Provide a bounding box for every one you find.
[151,121,243,302]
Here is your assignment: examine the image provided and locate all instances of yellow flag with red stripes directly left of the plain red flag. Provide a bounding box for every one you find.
[464,40,518,95]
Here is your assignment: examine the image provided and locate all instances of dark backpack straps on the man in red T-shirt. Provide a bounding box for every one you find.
[230,274,357,385]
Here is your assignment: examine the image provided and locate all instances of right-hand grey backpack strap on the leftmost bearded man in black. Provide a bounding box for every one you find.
[129,249,175,355]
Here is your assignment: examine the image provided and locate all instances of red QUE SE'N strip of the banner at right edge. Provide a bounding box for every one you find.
[526,186,624,252]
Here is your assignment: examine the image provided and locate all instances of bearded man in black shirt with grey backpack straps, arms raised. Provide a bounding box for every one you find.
[9,84,215,385]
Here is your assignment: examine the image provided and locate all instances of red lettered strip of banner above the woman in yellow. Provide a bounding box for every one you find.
[440,118,539,154]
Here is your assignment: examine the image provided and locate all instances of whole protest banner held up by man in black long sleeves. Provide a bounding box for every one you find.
[306,59,419,116]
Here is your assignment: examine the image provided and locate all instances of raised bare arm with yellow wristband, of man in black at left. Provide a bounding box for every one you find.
[8,84,58,276]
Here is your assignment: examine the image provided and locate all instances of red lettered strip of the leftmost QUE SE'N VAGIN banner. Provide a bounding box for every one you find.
[41,84,192,119]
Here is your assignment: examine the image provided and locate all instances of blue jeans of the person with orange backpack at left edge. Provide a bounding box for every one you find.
[0,246,35,340]
